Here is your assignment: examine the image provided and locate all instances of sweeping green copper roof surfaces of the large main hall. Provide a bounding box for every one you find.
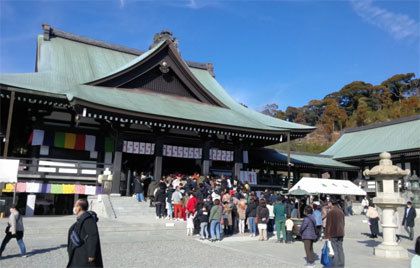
[0,24,314,133]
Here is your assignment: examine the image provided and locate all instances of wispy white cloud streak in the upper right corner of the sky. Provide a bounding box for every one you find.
[350,0,420,40]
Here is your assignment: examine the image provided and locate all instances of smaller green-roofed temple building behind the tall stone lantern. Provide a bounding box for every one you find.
[322,115,420,193]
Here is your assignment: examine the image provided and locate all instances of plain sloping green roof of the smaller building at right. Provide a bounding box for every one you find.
[322,115,420,159]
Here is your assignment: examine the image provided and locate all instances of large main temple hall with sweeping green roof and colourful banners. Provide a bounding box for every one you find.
[0,25,314,214]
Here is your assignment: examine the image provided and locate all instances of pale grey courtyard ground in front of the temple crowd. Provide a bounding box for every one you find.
[0,213,420,268]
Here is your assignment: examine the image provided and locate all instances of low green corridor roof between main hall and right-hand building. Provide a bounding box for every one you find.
[251,148,359,170]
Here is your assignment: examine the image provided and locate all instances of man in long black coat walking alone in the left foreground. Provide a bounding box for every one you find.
[67,199,103,267]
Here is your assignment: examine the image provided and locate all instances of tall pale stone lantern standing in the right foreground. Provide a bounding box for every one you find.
[363,152,410,258]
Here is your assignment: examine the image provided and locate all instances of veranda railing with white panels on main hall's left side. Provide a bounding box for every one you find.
[10,158,112,181]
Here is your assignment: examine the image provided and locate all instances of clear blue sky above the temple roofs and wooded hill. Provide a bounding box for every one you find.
[0,0,420,110]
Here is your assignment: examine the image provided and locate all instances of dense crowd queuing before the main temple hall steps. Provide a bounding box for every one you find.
[135,174,351,266]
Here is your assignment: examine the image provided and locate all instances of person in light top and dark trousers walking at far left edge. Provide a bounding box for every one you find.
[0,205,26,257]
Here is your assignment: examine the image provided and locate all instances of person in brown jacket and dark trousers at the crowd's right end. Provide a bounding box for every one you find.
[325,199,344,267]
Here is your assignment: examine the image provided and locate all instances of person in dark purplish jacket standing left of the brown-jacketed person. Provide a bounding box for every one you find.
[299,206,318,267]
